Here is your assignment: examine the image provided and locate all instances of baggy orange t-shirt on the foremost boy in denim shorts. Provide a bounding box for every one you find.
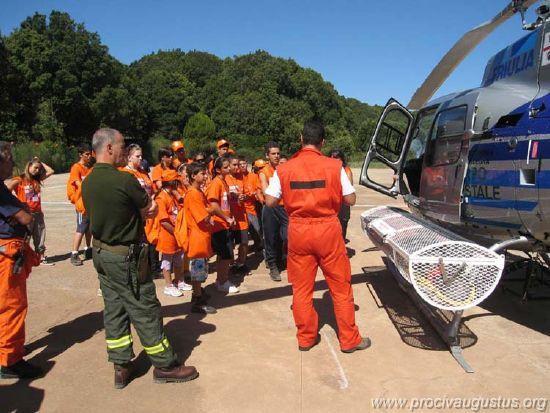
[183,187,213,258]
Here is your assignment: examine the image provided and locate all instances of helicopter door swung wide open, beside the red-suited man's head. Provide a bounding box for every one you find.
[359,98,413,198]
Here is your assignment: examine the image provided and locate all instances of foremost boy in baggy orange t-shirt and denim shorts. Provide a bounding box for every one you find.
[183,163,220,314]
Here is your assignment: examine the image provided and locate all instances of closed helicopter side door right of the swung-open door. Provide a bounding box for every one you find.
[420,104,473,224]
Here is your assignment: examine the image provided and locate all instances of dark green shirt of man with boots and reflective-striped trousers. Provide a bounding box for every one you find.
[82,163,149,245]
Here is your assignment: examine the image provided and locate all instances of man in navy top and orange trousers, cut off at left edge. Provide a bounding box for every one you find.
[0,141,42,379]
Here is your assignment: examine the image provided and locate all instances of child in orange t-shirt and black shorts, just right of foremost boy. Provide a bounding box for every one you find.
[206,157,239,294]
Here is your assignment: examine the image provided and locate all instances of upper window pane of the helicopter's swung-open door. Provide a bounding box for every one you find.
[376,110,409,162]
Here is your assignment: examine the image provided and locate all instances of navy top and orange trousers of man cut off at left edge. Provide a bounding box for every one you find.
[0,182,40,367]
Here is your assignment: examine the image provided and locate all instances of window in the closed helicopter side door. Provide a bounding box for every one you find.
[428,106,468,166]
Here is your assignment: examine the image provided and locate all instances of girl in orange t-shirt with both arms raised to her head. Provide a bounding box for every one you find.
[6,157,54,265]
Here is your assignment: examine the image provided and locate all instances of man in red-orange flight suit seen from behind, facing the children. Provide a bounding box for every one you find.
[265,121,371,353]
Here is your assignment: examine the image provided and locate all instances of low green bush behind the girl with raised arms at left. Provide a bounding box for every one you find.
[13,141,78,174]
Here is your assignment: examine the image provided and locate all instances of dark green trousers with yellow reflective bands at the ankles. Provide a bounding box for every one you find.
[93,247,177,368]
